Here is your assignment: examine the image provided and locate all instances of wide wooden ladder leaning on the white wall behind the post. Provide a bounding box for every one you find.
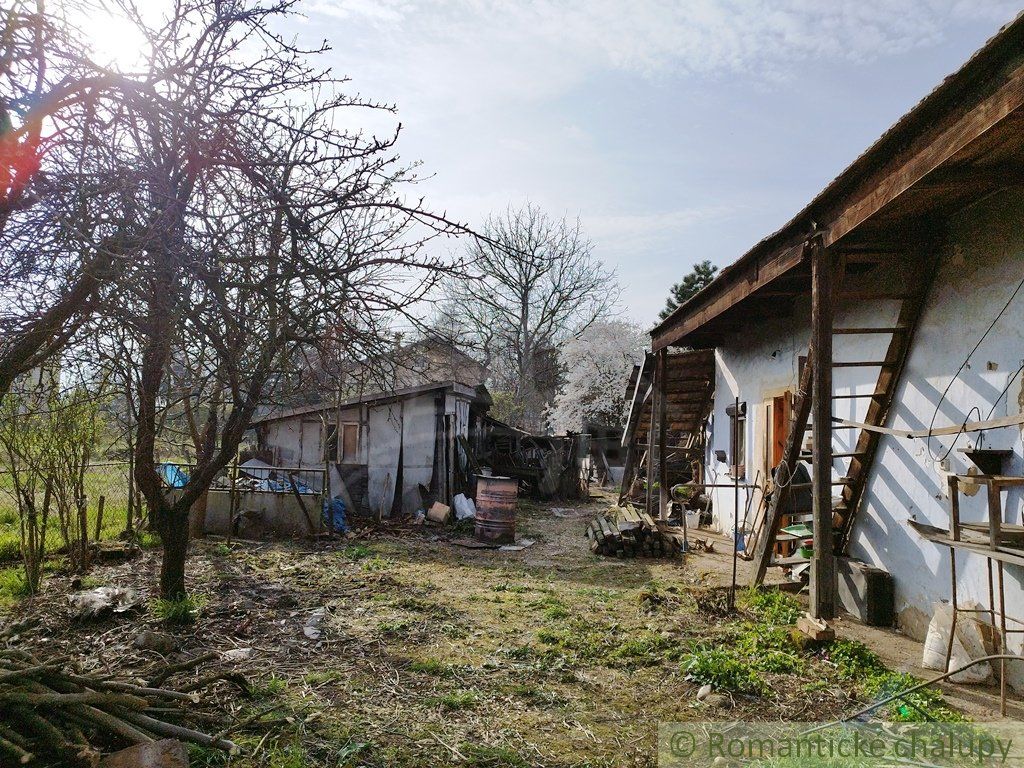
[753,250,936,585]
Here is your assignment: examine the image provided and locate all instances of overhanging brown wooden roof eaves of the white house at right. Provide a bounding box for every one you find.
[651,15,1024,351]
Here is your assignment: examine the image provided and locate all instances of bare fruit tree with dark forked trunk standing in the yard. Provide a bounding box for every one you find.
[83,0,465,599]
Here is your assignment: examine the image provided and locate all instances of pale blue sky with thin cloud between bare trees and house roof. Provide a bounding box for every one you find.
[297,0,1019,325]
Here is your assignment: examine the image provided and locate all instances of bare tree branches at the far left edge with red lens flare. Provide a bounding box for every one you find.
[0,0,144,395]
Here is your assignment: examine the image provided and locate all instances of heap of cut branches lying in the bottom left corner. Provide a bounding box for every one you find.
[0,649,238,766]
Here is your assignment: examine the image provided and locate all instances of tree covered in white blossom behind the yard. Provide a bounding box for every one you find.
[548,321,649,432]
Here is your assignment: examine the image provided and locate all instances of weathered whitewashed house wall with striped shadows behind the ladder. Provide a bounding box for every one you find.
[709,191,1024,684]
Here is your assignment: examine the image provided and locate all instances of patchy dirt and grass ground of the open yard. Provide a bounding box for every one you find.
[4,498,1019,768]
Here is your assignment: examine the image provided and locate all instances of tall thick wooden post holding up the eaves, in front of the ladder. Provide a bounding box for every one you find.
[811,239,837,620]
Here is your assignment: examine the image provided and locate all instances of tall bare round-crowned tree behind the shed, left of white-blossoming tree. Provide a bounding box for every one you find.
[436,204,618,431]
